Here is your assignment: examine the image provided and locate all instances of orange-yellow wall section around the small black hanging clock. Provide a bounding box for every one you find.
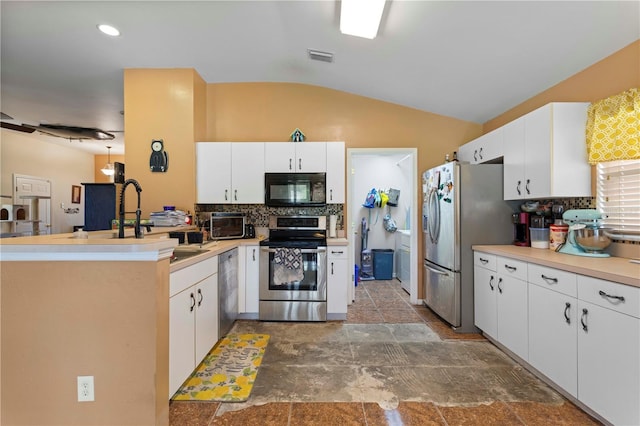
[124,69,206,217]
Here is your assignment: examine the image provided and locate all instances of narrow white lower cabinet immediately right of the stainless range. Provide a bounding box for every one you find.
[327,246,349,319]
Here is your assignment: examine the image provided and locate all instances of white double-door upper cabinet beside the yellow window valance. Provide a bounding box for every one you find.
[503,102,591,200]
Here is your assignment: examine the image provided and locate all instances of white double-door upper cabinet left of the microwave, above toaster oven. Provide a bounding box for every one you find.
[196,142,264,204]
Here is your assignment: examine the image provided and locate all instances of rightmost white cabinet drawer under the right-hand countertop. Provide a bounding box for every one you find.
[578,275,640,318]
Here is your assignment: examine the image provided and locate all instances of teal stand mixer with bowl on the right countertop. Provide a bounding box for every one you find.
[556,209,611,257]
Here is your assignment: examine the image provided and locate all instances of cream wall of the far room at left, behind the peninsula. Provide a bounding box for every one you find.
[0,129,94,233]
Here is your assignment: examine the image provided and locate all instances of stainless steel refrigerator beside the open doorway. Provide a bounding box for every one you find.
[422,162,513,333]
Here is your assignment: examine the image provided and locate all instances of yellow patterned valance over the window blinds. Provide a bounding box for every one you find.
[587,88,640,164]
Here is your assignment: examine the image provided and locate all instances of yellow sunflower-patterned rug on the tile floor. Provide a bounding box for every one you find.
[172,334,269,402]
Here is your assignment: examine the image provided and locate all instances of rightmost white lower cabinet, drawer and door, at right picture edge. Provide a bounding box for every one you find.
[578,276,640,425]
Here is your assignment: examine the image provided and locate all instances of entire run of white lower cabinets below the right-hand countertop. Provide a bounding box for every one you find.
[474,248,640,425]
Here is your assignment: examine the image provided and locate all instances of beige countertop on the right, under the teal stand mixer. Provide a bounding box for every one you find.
[472,245,640,287]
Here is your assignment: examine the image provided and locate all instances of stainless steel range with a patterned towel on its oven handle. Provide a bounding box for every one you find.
[258,216,327,321]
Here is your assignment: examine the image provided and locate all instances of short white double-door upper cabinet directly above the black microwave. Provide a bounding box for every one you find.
[264,142,327,173]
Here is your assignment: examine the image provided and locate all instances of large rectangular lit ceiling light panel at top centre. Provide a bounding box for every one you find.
[340,0,385,39]
